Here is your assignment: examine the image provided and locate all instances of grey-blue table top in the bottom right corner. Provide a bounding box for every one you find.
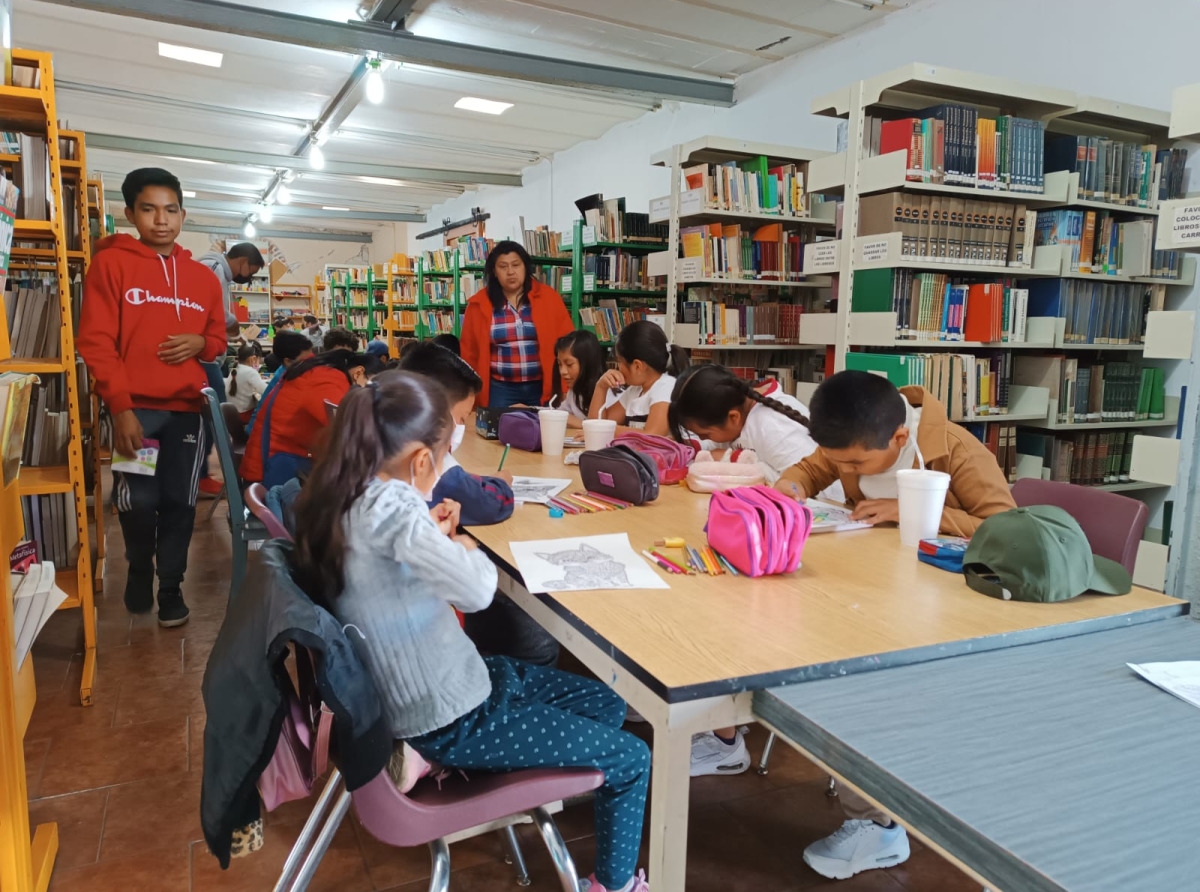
[754,618,1200,892]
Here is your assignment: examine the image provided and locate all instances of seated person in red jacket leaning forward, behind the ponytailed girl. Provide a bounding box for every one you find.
[238,351,383,489]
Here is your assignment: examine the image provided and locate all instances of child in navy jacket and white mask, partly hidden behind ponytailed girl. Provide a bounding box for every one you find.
[400,342,558,666]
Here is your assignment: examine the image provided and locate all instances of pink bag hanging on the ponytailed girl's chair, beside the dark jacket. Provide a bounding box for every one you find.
[258,647,334,812]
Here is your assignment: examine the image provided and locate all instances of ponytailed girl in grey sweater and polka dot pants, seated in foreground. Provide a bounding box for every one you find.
[295,371,650,892]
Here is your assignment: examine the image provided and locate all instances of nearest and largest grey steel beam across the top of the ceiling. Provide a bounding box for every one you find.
[47,0,733,106]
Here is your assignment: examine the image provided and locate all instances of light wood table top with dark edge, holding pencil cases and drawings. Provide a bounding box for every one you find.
[455,431,1187,702]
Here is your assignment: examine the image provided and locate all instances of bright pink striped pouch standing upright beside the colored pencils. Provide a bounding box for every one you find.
[706,486,812,576]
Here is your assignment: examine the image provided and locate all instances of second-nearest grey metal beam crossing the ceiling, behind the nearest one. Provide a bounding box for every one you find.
[86,132,521,186]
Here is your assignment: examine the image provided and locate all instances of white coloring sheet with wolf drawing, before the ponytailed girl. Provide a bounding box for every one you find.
[510,533,671,594]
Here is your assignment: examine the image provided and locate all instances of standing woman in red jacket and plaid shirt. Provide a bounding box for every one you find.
[462,241,575,407]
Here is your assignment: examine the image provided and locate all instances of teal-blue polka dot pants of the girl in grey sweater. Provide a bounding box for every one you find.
[408,657,650,890]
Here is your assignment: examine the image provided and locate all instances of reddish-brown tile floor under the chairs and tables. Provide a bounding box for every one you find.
[25,503,979,892]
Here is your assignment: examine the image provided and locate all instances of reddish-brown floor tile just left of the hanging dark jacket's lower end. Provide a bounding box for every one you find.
[100,773,204,861]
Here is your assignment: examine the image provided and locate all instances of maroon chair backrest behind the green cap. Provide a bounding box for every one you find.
[1013,478,1150,575]
